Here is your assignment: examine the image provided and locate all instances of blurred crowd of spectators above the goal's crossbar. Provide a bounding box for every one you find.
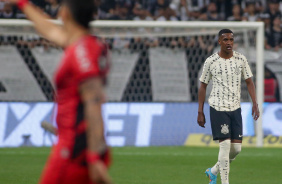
[0,0,282,51]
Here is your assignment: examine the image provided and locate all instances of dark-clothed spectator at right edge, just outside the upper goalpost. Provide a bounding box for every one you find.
[266,16,282,51]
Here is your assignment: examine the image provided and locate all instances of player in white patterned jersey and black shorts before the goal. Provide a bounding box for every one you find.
[198,29,260,184]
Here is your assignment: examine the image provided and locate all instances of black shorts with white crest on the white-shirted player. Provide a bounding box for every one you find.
[210,107,243,140]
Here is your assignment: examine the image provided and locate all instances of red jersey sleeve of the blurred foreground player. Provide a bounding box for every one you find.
[72,42,101,82]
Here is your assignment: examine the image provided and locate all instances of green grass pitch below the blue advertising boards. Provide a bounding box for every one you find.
[0,147,282,184]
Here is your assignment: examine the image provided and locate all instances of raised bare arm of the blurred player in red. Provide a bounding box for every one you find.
[7,0,67,47]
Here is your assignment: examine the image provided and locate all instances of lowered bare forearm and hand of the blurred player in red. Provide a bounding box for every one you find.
[79,78,112,184]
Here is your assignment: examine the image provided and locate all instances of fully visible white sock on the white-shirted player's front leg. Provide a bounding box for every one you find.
[218,140,231,184]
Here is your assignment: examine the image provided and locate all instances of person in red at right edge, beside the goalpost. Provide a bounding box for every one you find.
[264,68,280,102]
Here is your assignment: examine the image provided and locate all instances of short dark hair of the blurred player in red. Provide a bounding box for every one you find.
[63,0,96,29]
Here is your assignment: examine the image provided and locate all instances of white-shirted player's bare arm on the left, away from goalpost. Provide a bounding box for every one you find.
[197,82,207,128]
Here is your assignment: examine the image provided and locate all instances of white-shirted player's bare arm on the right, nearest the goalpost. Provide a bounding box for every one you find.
[245,78,260,120]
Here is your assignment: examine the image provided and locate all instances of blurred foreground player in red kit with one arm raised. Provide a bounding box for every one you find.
[8,0,112,184]
